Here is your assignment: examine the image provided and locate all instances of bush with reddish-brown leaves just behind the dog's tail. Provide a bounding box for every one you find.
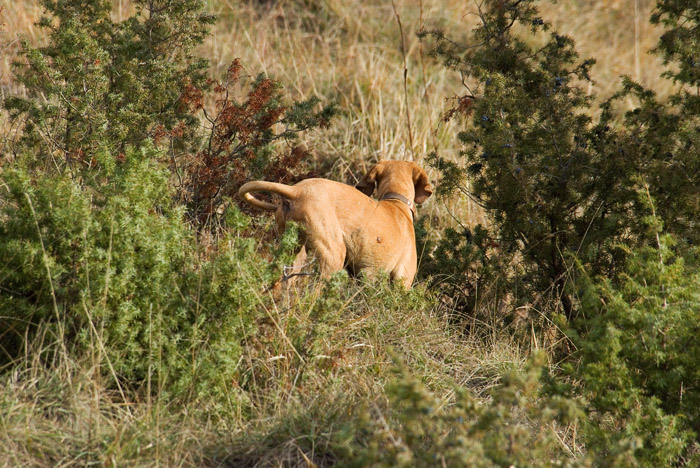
[176,59,336,224]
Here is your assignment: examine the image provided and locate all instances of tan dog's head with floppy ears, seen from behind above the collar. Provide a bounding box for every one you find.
[355,161,433,205]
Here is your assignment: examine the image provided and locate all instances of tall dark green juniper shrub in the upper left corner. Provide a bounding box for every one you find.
[4,0,213,168]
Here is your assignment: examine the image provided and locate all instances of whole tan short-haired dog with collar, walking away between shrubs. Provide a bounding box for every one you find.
[238,161,433,288]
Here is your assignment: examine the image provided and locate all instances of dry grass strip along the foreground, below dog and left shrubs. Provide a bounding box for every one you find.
[0,276,523,467]
